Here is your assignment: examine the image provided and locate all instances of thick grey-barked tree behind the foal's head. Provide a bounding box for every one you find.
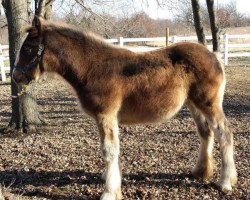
[2,0,52,132]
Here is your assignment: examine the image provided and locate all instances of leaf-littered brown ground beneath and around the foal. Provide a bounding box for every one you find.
[0,66,250,200]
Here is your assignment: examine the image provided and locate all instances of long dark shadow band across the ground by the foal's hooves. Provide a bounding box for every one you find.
[0,169,225,200]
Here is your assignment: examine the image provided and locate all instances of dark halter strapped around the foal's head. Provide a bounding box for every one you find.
[13,38,44,79]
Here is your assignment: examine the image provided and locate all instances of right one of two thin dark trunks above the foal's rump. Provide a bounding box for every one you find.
[206,0,220,52]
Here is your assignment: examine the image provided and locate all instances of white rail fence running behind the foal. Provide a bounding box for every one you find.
[0,34,250,81]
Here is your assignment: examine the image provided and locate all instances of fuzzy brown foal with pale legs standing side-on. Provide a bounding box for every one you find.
[13,17,237,200]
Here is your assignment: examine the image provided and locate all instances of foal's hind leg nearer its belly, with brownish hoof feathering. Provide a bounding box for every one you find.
[187,102,214,180]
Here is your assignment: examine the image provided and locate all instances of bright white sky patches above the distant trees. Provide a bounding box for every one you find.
[141,0,250,19]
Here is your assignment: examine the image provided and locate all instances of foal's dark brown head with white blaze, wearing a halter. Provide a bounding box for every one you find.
[12,16,44,84]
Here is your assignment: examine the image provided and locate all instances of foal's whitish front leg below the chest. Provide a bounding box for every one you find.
[97,114,122,200]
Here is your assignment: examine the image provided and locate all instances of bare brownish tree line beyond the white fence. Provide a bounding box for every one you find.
[0,0,250,43]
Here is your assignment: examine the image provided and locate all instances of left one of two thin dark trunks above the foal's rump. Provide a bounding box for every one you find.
[191,0,206,45]
